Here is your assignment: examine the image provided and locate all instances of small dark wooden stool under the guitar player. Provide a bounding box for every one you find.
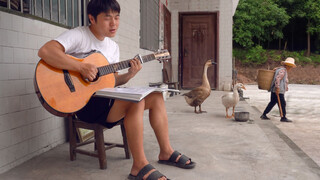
[68,115,130,169]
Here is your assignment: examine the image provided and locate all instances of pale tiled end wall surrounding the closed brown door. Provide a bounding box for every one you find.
[168,0,232,90]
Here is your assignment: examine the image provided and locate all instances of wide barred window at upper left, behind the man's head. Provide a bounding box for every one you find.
[0,0,89,27]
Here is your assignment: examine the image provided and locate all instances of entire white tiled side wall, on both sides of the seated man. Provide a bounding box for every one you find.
[0,0,162,173]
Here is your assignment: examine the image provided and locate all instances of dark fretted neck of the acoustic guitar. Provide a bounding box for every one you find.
[98,54,156,76]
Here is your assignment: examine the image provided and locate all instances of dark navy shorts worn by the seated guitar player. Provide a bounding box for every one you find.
[76,97,121,129]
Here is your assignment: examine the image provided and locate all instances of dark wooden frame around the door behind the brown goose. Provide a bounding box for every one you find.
[178,11,220,89]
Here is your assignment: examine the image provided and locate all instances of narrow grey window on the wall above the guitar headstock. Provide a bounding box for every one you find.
[140,0,159,51]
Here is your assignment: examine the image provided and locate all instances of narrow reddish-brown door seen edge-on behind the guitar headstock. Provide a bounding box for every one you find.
[163,6,172,82]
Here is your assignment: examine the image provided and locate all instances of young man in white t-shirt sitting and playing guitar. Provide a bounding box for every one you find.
[38,0,195,180]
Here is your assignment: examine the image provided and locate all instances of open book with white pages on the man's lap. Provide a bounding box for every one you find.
[95,87,180,102]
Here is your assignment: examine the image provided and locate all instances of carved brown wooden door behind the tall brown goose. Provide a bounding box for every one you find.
[179,13,218,89]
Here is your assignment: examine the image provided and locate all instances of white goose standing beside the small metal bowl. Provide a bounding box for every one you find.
[221,83,246,118]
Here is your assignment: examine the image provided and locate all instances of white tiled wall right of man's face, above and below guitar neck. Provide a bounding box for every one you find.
[114,0,162,86]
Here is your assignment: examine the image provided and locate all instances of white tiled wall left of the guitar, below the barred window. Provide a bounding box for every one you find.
[0,12,65,173]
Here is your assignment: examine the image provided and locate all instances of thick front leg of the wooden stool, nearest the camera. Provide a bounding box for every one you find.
[94,127,107,169]
